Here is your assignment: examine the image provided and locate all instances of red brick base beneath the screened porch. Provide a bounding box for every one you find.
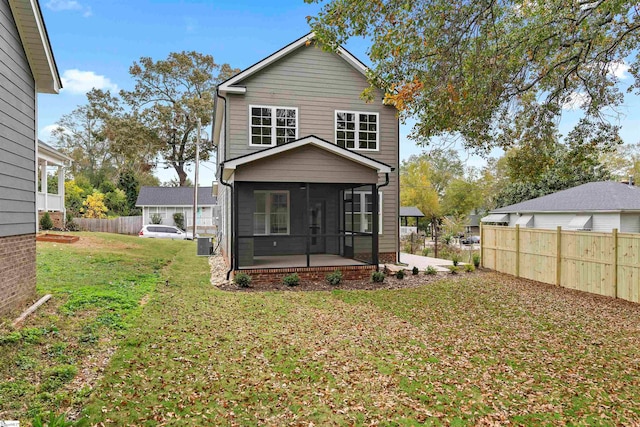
[234,265,376,286]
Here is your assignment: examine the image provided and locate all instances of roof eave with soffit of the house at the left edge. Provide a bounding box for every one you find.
[9,0,62,93]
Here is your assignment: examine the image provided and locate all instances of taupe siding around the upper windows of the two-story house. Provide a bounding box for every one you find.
[226,45,399,252]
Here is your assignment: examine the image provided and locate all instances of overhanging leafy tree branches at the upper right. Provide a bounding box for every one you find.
[306,0,640,153]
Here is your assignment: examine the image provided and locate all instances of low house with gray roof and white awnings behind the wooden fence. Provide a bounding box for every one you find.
[482,182,640,233]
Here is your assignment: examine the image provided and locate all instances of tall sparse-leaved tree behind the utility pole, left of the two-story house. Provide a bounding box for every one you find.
[120,51,239,186]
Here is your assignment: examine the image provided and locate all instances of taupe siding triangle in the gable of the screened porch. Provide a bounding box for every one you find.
[235,146,378,184]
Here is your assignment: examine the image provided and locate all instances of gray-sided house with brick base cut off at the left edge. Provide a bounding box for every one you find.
[0,0,62,314]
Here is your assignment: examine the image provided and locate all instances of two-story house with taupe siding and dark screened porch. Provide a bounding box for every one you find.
[213,33,399,281]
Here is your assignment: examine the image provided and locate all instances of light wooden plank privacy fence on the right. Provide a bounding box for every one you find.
[480,226,640,302]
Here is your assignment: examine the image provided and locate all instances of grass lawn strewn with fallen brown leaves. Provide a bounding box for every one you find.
[0,235,640,426]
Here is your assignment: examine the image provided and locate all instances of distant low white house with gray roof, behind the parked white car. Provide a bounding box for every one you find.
[136,187,216,232]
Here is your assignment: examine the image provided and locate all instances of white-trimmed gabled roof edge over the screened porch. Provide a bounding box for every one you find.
[222,135,394,181]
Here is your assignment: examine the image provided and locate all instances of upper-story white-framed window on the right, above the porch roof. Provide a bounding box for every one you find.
[336,111,379,151]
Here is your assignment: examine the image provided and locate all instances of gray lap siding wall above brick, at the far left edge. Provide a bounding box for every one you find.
[0,1,36,237]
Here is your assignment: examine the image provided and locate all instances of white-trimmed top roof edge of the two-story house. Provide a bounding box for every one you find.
[218,32,367,93]
